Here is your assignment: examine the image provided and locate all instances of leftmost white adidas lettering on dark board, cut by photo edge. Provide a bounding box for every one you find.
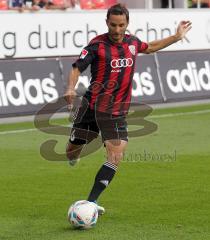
[0,72,58,107]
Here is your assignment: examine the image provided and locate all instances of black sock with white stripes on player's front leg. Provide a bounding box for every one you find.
[88,162,117,202]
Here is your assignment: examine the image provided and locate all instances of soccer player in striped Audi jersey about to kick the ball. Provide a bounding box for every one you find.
[65,4,191,214]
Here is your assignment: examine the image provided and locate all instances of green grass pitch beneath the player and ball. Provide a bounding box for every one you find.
[0,104,210,240]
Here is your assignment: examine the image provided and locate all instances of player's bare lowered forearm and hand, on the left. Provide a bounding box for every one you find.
[65,67,81,105]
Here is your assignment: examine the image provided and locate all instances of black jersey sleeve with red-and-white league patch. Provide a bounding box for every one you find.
[72,44,97,72]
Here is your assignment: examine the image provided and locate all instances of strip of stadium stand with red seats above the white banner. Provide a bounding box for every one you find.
[0,0,210,12]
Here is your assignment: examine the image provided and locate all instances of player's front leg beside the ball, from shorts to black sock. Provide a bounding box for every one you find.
[88,113,128,207]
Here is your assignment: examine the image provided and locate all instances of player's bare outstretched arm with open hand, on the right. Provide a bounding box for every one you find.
[143,21,192,54]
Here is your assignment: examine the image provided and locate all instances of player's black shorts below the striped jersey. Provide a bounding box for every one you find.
[69,108,128,145]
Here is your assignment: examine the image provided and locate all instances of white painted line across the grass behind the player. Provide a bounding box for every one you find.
[0,109,210,135]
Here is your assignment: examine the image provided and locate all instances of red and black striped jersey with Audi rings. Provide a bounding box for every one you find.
[73,33,148,115]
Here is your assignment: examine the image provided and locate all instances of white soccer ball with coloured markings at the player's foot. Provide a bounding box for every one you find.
[68,200,98,229]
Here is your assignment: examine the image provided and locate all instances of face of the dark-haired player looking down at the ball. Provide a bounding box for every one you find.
[106,14,128,43]
